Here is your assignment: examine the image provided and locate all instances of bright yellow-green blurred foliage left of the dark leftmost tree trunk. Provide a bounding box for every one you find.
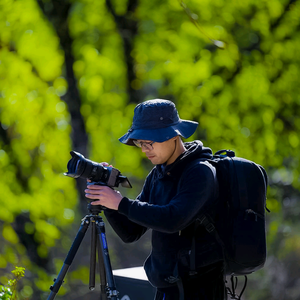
[0,0,77,294]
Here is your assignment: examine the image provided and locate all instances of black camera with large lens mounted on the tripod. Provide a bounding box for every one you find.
[64,151,132,188]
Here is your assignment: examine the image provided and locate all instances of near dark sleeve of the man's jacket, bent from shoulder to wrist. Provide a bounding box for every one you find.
[119,162,218,233]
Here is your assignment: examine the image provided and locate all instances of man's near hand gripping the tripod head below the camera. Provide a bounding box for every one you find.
[85,184,123,210]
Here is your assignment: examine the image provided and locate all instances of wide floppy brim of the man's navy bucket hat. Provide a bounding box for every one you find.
[119,119,198,146]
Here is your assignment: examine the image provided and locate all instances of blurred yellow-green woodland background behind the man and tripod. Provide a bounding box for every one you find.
[0,0,300,300]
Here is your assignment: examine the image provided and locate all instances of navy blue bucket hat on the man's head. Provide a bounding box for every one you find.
[119,99,198,146]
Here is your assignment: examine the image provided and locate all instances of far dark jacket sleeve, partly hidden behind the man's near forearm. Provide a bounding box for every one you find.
[104,169,155,243]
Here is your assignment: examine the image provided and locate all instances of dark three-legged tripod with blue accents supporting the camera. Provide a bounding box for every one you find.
[47,203,118,300]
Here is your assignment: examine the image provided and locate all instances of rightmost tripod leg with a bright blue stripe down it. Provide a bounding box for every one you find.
[96,218,118,300]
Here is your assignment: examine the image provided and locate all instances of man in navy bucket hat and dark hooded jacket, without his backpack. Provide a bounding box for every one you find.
[85,99,226,300]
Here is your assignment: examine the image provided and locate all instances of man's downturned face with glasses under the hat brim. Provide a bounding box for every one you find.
[137,137,176,165]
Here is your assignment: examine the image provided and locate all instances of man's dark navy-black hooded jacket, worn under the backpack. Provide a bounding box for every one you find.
[105,141,223,288]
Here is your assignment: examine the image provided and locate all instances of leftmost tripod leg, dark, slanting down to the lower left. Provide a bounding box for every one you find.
[47,217,90,300]
